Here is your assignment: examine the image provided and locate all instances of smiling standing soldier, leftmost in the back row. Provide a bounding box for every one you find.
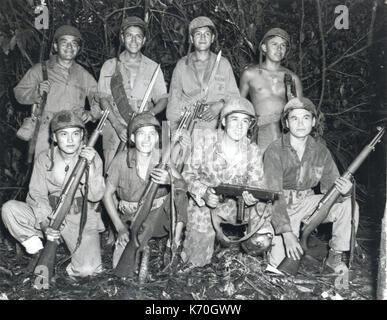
[14,25,100,157]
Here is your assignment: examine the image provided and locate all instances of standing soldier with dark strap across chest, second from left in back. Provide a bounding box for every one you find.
[98,17,168,169]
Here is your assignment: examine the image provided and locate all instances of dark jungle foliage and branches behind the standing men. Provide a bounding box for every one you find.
[0,0,387,203]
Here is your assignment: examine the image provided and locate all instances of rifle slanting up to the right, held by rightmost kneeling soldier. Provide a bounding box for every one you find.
[277,127,385,276]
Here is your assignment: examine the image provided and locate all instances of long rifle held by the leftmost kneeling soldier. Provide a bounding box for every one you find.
[34,109,110,282]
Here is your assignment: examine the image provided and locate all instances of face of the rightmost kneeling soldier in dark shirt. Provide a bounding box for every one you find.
[286,109,316,138]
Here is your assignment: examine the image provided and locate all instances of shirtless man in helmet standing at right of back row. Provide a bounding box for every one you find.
[239,28,302,152]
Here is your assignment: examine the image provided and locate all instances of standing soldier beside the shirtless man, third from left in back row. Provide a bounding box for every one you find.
[167,17,239,131]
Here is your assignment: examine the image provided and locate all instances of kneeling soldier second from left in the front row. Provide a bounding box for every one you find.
[103,111,185,268]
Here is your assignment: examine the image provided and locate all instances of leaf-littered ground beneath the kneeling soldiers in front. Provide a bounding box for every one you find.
[0,218,379,300]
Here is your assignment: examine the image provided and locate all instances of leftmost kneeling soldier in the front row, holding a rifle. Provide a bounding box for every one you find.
[2,111,105,277]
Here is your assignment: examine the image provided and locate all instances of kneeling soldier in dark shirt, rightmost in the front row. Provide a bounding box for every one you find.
[264,97,359,272]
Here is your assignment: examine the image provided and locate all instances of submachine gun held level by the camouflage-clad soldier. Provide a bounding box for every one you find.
[213,183,281,224]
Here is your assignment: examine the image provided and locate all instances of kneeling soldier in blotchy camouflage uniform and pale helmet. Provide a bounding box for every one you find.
[181,98,272,267]
